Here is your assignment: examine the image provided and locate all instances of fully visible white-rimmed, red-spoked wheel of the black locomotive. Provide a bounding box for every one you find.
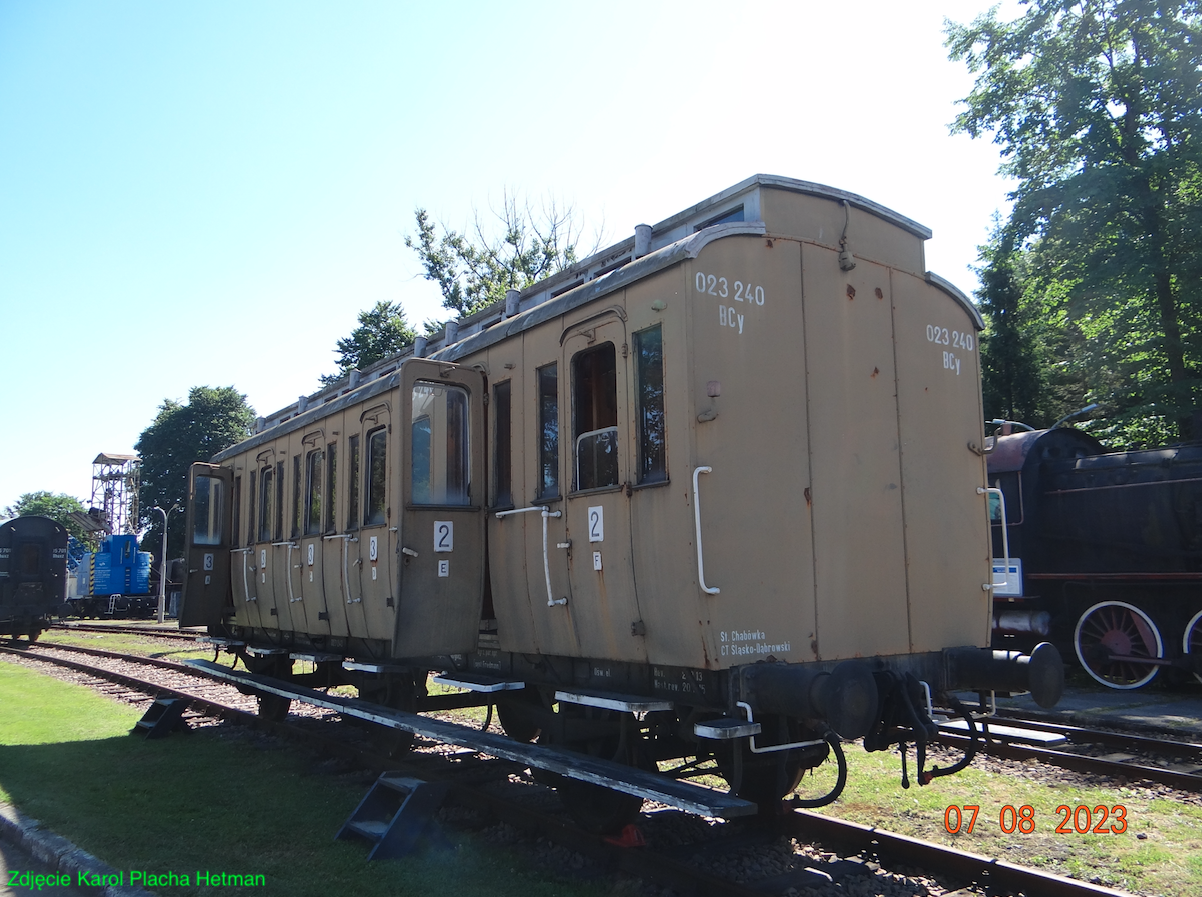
[1072,601,1165,689]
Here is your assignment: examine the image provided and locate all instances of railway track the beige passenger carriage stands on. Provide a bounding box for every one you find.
[0,646,1139,897]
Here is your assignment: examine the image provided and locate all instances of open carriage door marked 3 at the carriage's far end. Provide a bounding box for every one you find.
[179,463,233,626]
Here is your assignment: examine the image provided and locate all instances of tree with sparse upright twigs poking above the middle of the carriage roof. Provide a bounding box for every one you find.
[405,192,600,315]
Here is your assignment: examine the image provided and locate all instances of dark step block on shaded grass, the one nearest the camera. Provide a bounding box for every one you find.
[334,772,451,860]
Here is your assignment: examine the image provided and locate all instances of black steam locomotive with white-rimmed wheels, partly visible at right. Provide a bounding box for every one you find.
[988,427,1202,689]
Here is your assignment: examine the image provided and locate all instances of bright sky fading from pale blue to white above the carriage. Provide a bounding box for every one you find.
[0,0,1012,509]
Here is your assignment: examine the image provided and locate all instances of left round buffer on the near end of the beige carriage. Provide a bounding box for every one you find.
[738,660,879,738]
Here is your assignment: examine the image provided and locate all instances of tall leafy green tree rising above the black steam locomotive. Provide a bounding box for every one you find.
[946,0,1202,442]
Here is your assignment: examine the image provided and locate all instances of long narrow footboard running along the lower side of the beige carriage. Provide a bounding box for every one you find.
[184,660,758,819]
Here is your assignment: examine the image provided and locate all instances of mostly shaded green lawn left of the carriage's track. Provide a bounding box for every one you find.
[0,663,602,897]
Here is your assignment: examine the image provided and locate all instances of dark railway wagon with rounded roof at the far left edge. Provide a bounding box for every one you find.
[0,517,67,641]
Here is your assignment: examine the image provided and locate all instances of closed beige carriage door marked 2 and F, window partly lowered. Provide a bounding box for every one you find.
[563,309,647,661]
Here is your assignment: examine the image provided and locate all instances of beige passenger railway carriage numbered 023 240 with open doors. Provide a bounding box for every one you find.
[182,176,1059,822]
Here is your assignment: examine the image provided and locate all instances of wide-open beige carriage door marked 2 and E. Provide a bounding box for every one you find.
[393,358,487,657]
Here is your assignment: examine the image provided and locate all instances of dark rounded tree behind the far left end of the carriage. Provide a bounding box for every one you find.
[133,386,255,557]
